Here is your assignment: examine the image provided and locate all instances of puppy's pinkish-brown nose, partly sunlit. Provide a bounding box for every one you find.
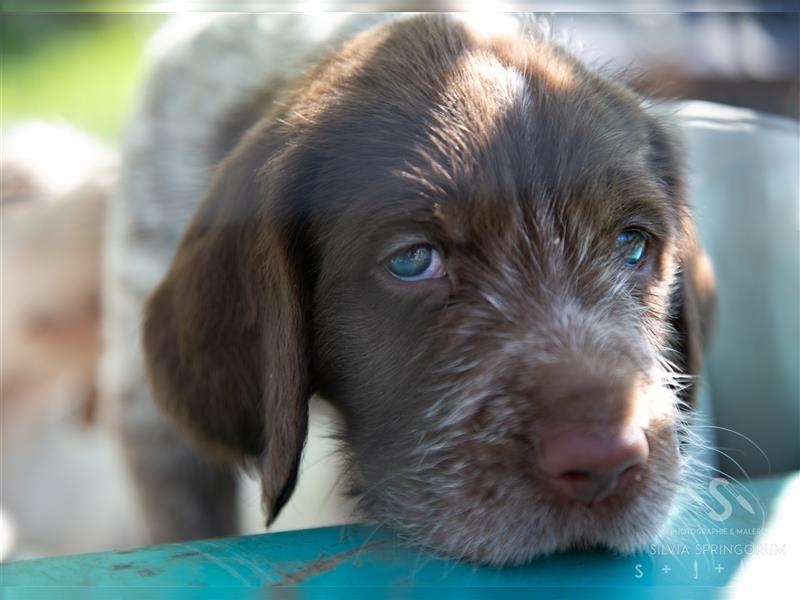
[538,426,650,504]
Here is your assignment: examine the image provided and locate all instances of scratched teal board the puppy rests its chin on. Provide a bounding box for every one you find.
[0,473,800,598]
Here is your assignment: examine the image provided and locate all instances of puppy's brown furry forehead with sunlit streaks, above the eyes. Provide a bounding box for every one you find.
[310,19,659,246]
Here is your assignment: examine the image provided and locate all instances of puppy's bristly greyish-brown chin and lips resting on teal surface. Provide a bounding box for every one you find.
[350,426,681,566]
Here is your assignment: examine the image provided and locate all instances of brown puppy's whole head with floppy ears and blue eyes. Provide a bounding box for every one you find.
[145,17,709,563]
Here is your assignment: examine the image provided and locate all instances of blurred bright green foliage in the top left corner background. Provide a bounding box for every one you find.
[0,13,163,140]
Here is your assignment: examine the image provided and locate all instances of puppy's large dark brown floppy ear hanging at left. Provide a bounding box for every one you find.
[143,130,311,521]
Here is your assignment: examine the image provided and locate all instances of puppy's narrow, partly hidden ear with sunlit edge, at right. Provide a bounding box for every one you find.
[649,116,716,407]
